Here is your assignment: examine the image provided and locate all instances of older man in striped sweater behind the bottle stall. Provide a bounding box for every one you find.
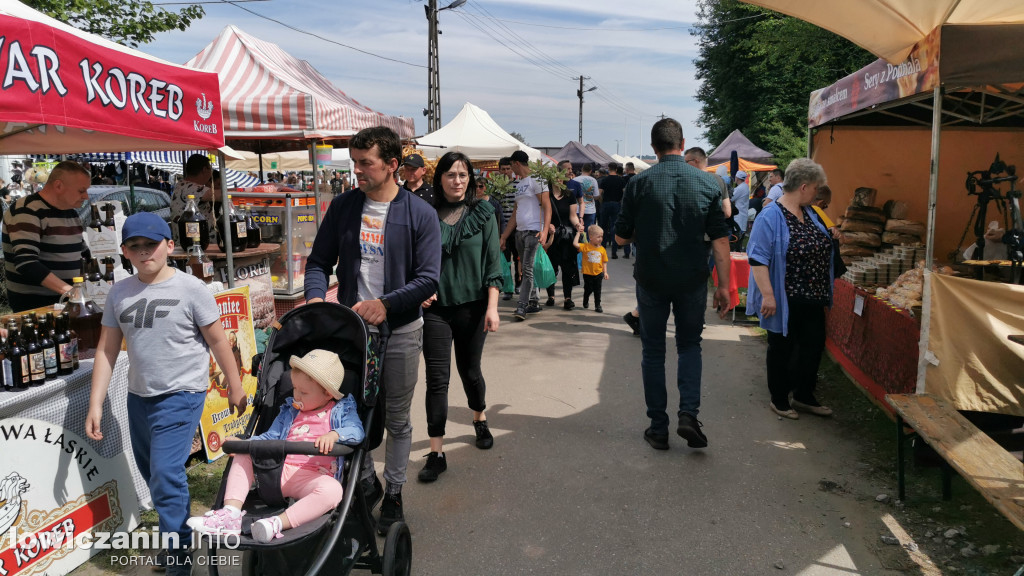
[3,162,90,312]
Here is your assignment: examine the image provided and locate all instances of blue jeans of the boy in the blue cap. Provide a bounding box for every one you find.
[128,392,206,546]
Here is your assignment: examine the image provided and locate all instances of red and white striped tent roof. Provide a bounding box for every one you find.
[185,26,416,139]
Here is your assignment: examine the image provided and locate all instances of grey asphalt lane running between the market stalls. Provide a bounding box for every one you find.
[81,259,905,576]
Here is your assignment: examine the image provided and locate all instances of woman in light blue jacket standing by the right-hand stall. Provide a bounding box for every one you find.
[746,158,834,420]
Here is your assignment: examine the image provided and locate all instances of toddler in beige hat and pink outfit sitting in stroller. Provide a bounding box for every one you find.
[188,349,365,544]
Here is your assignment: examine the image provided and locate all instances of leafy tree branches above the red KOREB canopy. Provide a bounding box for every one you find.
[23,0,206,46]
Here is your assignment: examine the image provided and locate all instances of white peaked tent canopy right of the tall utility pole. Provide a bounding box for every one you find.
[416,102,544,160]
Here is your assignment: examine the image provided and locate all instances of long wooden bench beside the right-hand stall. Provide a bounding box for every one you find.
[886,394,1024,530]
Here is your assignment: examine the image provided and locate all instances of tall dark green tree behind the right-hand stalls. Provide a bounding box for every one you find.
[694,0,874,166]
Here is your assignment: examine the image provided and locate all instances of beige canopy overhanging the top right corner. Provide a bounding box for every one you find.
[744,0,1024,64]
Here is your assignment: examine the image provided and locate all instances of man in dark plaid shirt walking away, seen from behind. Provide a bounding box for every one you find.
[615,118,729,450]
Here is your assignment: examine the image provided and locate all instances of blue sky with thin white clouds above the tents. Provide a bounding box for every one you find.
[141,0,711,155]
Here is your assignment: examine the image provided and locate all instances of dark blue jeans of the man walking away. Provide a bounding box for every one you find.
[637,284,708,434]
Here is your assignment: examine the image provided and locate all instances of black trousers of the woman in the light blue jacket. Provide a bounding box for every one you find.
[767,300,825,410]
